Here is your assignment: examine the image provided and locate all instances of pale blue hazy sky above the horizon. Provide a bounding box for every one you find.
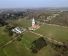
[0,0,68,9]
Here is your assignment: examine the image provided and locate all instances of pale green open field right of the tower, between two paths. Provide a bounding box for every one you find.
[35,24,68,42]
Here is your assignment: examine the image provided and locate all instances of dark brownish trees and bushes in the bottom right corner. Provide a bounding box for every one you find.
[50,42,68,56]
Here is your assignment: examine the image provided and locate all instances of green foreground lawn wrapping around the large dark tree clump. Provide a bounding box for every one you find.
[1,32,54,56]
